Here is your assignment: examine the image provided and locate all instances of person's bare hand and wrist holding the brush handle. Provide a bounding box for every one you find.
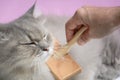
[65,6,120,45]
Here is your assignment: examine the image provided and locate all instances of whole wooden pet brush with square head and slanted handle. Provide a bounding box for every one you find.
[47,27,87,80]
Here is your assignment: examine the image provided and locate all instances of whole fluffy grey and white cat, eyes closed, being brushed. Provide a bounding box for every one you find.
[0,4,120,80]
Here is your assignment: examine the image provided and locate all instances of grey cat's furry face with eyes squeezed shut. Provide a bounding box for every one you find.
[0,5,53,67]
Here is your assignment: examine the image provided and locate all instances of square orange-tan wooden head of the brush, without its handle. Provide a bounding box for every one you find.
[47,41,82,80]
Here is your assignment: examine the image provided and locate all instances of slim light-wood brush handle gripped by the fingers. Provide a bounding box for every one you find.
[65,27,87,51]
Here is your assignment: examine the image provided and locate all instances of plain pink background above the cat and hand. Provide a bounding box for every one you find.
[0,0,120,23]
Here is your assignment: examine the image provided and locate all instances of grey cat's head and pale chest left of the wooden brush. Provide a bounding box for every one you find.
[0,6,54,80]
